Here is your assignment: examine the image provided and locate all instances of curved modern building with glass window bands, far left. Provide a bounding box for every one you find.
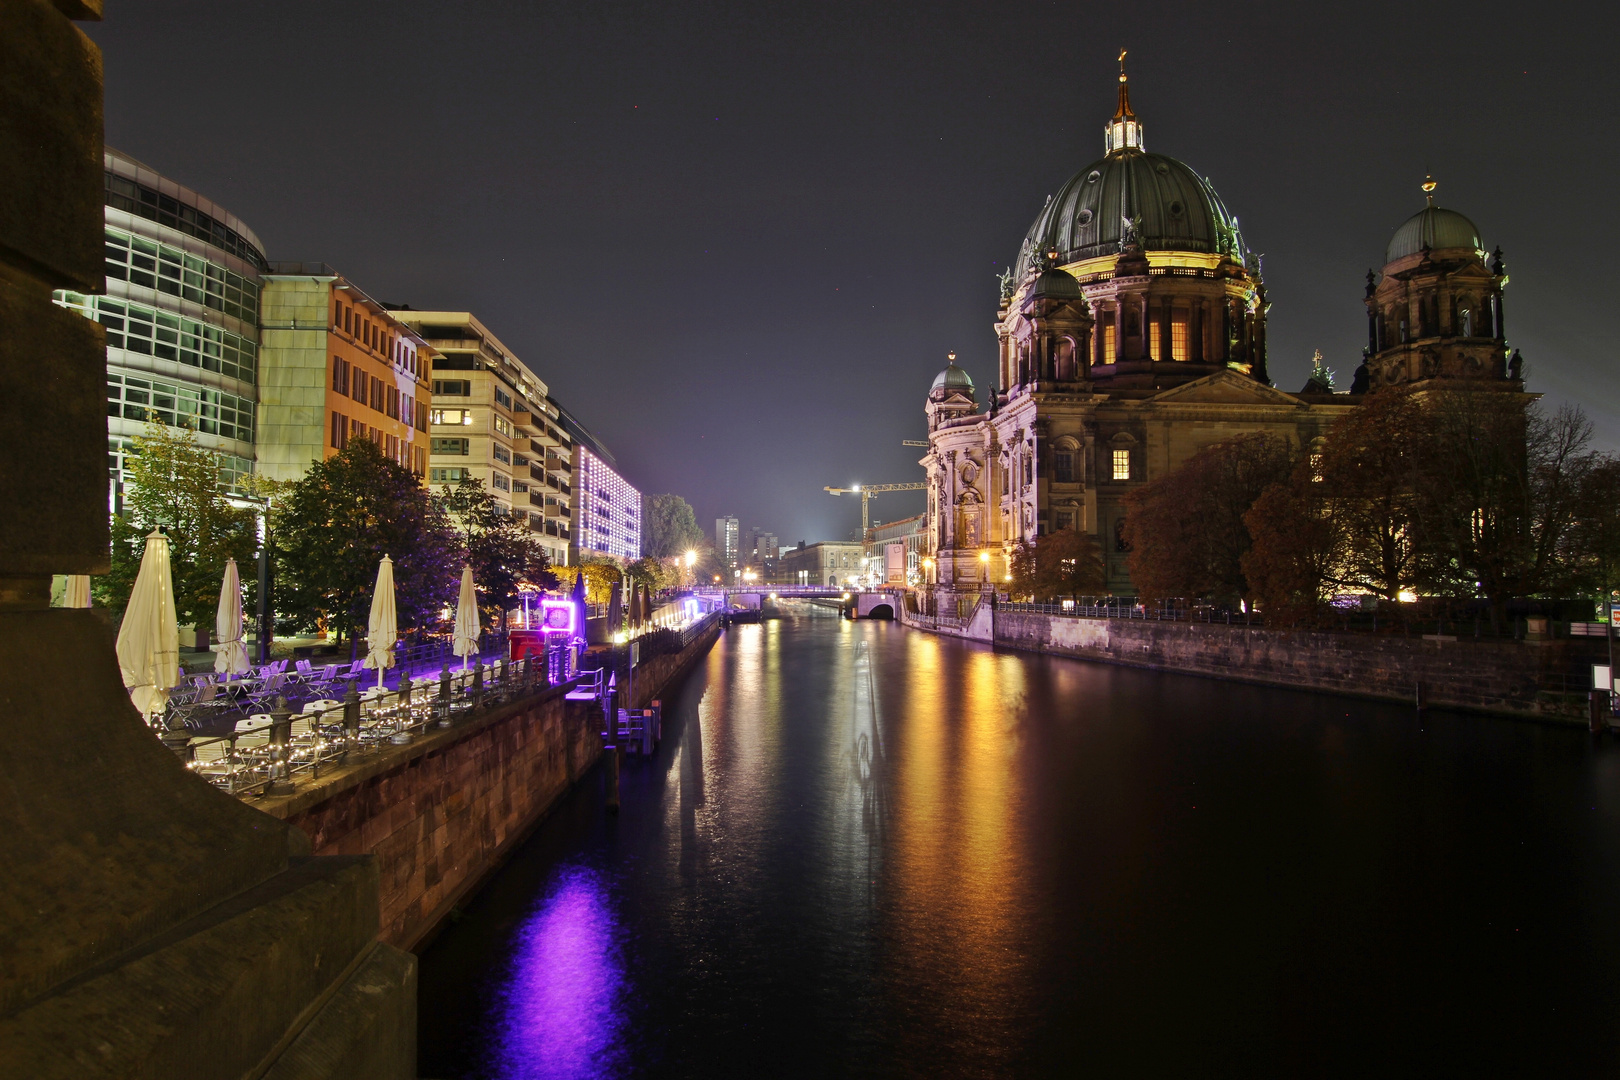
[55,149,266,508]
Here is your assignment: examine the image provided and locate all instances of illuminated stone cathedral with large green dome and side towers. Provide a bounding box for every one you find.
[922,57,1524,594]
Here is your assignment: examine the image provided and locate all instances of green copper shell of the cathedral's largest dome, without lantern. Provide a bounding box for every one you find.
[1021,147,1247,266]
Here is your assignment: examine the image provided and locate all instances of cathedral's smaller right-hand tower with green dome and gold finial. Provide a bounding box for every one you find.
[1366,178,1523,390]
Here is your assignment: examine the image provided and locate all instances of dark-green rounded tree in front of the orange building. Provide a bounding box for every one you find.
[272,439,463,638]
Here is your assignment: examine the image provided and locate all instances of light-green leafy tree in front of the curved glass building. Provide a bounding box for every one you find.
[96,421,259,627]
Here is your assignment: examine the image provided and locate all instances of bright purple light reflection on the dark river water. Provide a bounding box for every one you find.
[492,866,627,1080]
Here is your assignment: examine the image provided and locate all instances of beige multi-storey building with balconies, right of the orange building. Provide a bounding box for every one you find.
[390,308,573,567]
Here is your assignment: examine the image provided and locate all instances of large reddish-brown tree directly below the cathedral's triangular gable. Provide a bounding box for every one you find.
[1124,434,1293,606]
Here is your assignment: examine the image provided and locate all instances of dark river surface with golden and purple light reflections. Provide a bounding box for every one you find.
[420,617,1620,1078]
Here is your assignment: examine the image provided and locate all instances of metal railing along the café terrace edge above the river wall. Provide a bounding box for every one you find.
[164,646,577,797]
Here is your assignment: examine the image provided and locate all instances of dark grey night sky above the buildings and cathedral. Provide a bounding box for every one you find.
[86,0,1620,544]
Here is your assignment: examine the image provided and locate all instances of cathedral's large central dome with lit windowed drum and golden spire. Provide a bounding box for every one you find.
[996,53,1268,402]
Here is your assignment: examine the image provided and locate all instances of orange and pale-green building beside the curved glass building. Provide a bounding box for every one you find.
[258,262,433,479]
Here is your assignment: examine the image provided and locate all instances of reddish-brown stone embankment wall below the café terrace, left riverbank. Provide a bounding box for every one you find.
[253,625,719,949]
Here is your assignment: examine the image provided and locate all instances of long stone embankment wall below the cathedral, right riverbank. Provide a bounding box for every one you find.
[902,602,1607,724]
